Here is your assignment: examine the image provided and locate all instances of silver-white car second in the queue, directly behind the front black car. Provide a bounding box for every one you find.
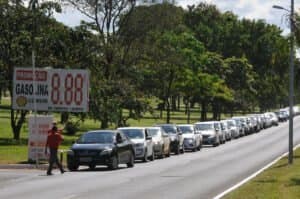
[118,127,155,162]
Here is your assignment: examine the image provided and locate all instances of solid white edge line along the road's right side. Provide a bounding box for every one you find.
[214,144,300,199]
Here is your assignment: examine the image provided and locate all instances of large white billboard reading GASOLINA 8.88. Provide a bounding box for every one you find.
[13,68,89,112]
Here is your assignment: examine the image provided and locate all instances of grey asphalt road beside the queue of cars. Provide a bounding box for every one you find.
[0,117,300,199]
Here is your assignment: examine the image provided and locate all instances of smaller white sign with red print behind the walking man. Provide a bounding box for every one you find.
[28,115,53,161]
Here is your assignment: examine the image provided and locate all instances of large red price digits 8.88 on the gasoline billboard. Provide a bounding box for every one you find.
[51,73,83,106]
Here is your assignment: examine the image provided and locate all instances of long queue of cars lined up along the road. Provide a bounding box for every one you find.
[67,105,298,171]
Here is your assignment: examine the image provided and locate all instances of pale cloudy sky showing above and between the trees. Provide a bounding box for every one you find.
[55,0,300,34]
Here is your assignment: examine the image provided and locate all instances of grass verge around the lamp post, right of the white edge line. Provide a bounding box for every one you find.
[224,149,300,199]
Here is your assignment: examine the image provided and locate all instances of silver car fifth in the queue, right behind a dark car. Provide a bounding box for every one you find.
[177,124,202,152]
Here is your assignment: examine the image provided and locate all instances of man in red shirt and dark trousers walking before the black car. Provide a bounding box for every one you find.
[45,122,65,175]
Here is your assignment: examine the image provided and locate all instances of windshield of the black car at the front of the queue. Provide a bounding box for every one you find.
[77,132,114,144]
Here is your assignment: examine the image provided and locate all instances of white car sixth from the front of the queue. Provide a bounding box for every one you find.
[195,122,221,146]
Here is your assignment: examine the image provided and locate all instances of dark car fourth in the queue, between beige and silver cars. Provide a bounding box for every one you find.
[155,124,184,154]
